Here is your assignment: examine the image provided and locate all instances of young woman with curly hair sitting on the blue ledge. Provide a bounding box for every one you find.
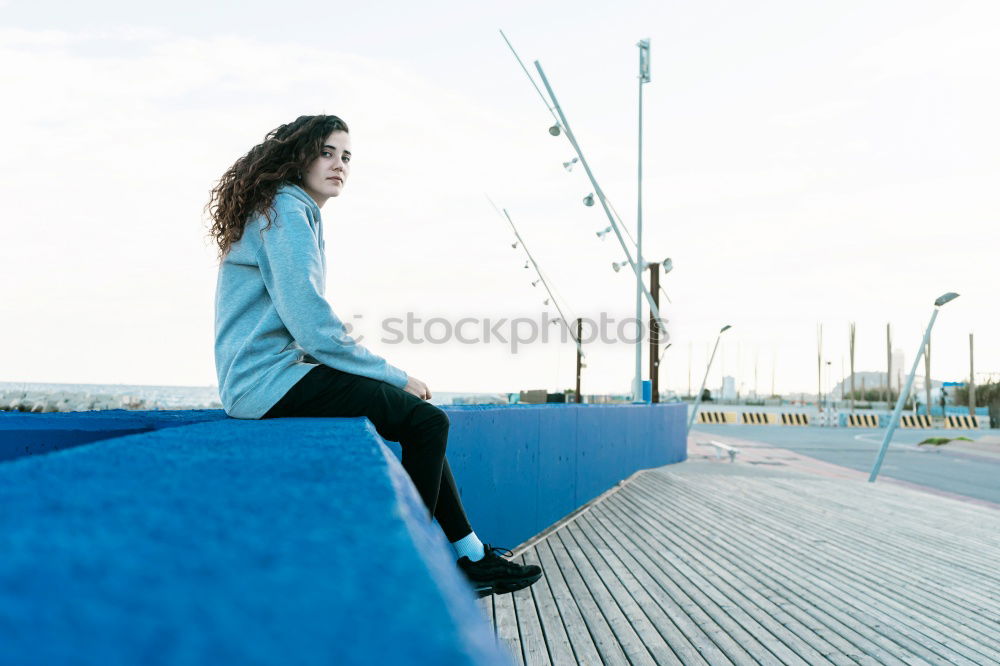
[206,115,542,596]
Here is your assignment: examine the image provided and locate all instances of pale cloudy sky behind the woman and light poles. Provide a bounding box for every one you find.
[0,0,1000,393]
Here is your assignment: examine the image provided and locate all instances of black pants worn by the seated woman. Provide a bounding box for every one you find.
[262,365,472,541]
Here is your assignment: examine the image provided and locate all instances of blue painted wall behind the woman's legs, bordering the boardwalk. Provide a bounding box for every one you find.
[382,403,687,548]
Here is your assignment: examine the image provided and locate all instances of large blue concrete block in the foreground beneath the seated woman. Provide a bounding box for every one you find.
[0,415,509,666]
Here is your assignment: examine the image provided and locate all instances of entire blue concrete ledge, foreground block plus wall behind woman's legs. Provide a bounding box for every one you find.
[0,404,686,666]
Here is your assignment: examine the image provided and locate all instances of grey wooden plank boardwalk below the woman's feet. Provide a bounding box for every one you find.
[480,438,1000,666]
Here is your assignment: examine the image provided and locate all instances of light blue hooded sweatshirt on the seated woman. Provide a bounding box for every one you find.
[215,184,409,419]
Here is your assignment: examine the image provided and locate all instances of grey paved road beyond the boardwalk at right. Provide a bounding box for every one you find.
[691,425,1000,504]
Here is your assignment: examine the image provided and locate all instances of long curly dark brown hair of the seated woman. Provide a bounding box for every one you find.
[205,115,348,262]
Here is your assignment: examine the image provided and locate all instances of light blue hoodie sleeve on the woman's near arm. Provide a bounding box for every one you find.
[257,201,409,388]
